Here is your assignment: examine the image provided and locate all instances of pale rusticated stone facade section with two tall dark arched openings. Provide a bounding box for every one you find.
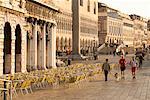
[0,0,26,75]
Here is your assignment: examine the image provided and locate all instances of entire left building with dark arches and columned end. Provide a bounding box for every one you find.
[0,0,58,75]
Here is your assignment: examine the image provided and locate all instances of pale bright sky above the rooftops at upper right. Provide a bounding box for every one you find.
[98,0,150,18]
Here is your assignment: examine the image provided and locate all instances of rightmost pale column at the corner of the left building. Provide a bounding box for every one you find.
[47,24,56,68]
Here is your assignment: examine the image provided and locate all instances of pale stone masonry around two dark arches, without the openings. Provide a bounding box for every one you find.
[0,0,26,75]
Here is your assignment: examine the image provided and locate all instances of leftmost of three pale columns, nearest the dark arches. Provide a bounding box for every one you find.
[31,22,37,69]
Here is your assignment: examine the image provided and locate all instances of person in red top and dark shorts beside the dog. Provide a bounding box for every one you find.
[119,56,126,79]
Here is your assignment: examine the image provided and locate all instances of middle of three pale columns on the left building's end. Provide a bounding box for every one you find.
[41,23,46,69]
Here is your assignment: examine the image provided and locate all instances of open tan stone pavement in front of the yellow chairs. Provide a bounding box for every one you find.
[14,67,150,100]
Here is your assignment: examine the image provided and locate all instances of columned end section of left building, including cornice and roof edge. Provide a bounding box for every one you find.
[25,0,58,70]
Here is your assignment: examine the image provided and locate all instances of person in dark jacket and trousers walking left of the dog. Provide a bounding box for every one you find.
[102,59,110,81]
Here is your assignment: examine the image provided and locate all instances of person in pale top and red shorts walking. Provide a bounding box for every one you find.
[130,57,137,79]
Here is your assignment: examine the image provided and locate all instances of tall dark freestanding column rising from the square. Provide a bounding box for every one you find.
[72,0,81,59]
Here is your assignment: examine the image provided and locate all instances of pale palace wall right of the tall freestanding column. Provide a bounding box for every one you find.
[80,0,98,52]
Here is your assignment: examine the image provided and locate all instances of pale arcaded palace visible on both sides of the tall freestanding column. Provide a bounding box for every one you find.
[52,0,98,53]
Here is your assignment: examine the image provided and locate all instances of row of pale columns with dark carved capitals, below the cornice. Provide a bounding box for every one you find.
[26,17,56,70]
